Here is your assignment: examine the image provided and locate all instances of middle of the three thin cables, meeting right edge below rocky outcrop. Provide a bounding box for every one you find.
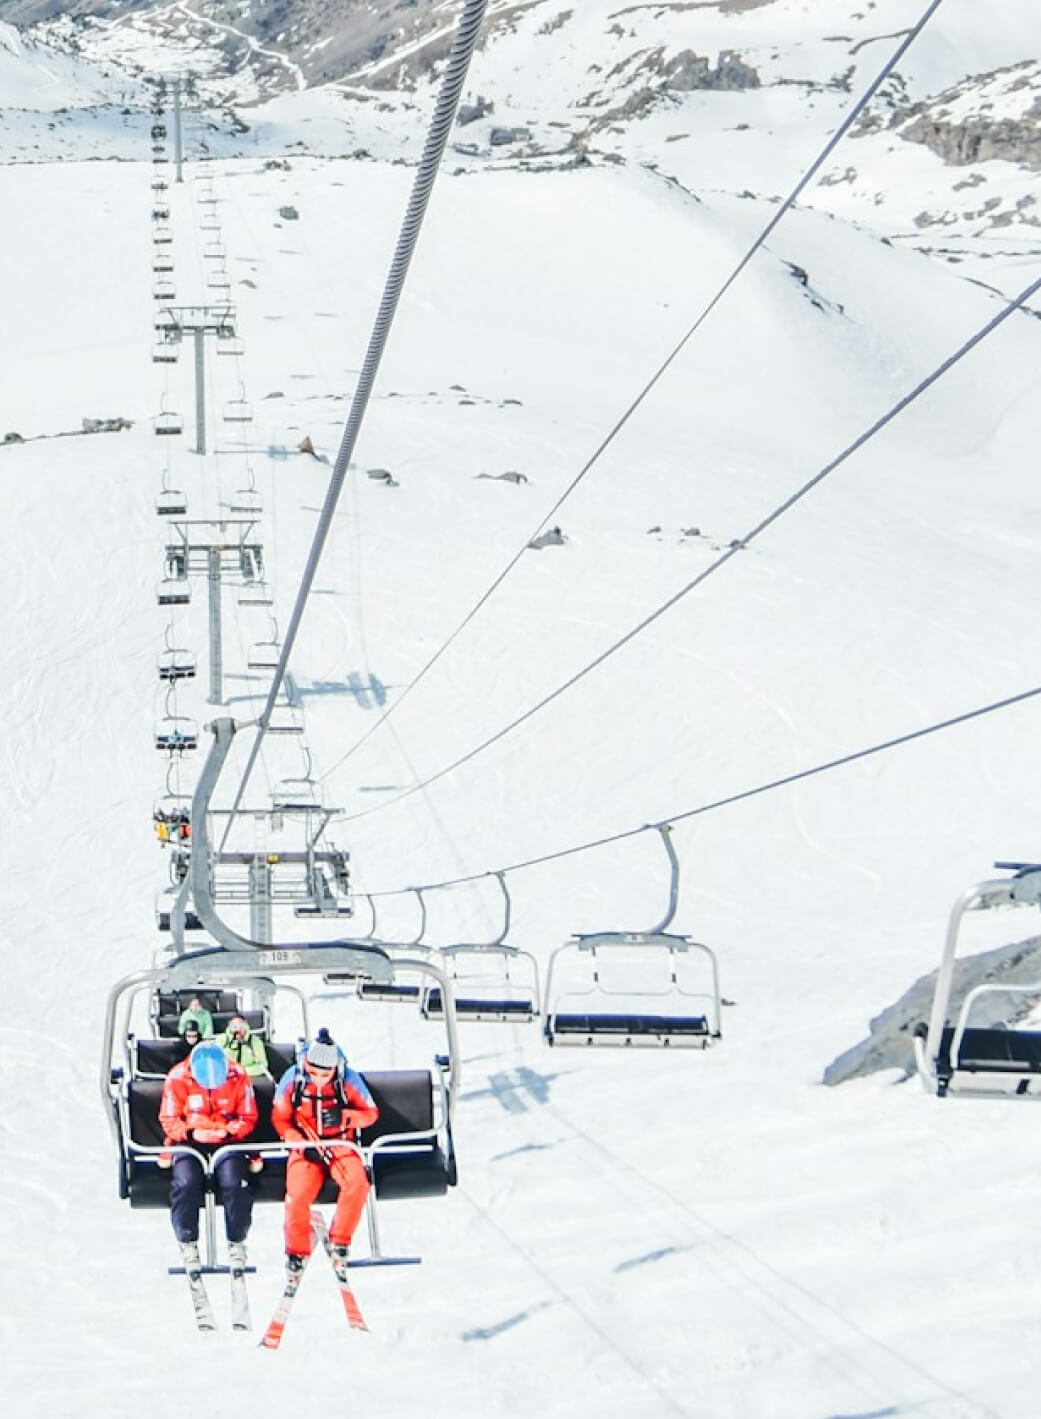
[345,265,1041,823]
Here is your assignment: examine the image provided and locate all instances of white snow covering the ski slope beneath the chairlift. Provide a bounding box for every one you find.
[0,0,1041,1419]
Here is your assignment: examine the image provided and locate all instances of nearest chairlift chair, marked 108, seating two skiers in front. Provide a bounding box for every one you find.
[99,942,460,1273]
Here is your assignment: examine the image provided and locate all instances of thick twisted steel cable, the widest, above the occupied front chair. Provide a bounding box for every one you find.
[220,0,488,847]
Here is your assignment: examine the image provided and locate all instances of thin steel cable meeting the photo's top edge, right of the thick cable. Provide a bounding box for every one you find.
[316,0,942,773]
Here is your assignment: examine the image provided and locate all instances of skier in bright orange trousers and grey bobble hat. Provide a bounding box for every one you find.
[271,1030,379,1270]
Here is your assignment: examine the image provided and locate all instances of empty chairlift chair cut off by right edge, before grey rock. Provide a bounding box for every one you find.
[913,863,1041,1100]
